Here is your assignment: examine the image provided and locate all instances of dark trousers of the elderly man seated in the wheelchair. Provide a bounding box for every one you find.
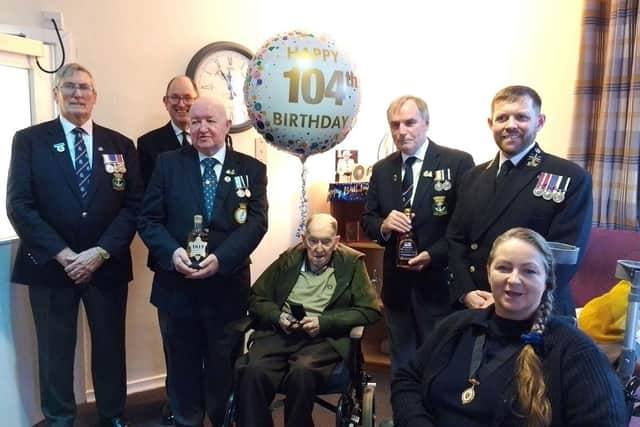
[237,332,342,427]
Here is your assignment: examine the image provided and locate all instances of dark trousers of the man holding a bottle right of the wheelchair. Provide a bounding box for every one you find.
[384,287,449,375]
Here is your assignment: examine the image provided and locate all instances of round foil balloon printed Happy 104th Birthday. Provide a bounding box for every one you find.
[244,31,360,161]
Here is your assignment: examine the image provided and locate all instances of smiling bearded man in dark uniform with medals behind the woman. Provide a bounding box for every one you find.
[447,86,593,317]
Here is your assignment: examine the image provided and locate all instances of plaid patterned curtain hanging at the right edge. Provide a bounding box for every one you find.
[569,0,640,231]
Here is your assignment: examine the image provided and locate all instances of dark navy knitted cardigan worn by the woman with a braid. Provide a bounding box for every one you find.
[391,307,629,427]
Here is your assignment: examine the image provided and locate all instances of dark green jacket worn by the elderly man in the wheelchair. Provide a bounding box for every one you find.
[249,244,380,360]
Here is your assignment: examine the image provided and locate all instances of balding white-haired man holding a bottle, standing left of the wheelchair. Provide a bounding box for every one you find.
[138,98,267,426]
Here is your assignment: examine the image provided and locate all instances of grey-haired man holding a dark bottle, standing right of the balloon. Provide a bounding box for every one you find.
[362,96,473,372]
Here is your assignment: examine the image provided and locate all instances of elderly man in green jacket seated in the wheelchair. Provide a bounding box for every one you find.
[227,214,380,427]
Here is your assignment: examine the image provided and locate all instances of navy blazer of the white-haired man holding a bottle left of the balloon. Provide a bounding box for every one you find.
[138,146,267,319]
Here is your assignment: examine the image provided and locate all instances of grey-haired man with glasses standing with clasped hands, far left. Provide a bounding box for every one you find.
[7,63,142,427]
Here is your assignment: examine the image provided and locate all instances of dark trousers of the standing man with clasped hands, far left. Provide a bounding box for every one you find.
[29,283,128,427]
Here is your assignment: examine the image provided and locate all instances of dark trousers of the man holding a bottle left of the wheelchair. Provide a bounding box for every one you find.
[158,307,242,427]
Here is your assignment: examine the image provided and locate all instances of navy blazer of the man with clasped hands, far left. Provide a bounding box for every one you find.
[7,119,142,287]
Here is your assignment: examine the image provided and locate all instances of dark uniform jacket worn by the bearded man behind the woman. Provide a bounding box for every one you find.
[447,144,593,316]
